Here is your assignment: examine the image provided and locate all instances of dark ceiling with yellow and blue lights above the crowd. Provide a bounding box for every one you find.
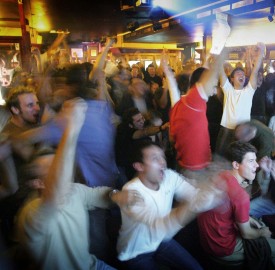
[0,0,275,46]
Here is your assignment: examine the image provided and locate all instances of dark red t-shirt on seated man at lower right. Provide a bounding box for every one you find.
[198,171,250,257]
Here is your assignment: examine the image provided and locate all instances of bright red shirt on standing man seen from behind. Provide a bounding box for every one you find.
[170,86,211,170]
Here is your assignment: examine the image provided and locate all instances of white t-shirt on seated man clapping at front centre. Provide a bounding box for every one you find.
[117,169,198,261]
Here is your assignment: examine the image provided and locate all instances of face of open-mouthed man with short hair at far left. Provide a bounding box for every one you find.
[18,93,40,124]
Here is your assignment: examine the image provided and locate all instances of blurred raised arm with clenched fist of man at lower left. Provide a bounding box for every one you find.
[43,99,87,206]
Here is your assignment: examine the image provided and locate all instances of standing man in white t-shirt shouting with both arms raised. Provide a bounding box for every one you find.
[216,43,265,155]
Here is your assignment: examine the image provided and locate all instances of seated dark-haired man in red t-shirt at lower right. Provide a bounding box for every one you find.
[198,142,275,262]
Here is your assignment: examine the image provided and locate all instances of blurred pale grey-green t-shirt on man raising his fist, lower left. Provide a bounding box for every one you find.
[17,183,110,270]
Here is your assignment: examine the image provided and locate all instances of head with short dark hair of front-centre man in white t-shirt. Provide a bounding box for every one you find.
[132,141,167,190]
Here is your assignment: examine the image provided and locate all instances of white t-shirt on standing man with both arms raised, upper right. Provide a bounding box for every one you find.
[221,79,255,129]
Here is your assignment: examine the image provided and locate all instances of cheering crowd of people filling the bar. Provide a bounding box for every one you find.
[0,28,275,270]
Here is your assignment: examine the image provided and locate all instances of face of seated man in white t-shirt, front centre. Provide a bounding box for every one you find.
[142,145,166,186]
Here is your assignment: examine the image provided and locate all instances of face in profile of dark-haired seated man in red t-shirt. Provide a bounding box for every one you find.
[238,152,259,181]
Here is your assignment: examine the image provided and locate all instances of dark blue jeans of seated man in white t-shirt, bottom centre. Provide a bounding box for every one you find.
[124,239,202,270]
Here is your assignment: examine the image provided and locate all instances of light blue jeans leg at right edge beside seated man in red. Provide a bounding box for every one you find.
[249,197,275,218]
